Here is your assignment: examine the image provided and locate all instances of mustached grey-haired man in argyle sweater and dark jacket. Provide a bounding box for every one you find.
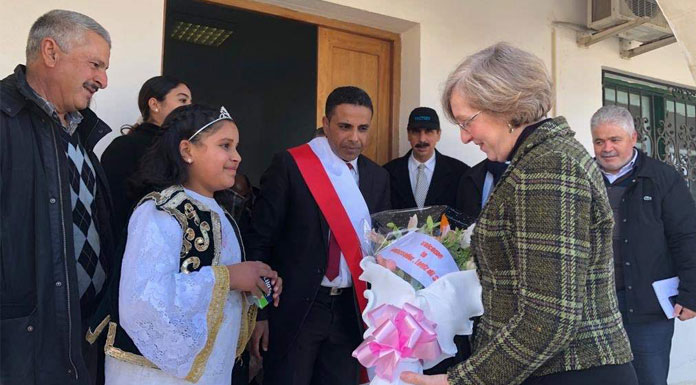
[0,10,113,385]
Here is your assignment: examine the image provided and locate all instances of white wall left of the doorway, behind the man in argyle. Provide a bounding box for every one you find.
[0,0,164,154]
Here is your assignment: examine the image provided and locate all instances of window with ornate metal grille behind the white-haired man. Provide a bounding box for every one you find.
[602,71,696,198]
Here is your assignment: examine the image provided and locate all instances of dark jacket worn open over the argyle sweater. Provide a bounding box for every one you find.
[0,66,113,385]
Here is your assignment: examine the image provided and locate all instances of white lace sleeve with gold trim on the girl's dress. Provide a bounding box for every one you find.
[119,201,229,382]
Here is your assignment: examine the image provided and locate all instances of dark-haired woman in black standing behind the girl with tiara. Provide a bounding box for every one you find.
[101,76,191,237]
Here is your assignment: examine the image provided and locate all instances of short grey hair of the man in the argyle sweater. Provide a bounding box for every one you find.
[26,9,111,64]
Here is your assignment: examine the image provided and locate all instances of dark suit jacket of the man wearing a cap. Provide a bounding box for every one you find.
[384,150,469,209]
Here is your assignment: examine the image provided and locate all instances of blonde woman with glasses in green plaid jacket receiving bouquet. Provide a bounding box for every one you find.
[402,43,637,385]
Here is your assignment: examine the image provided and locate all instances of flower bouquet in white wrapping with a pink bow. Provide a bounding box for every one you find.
[353,206,483,385]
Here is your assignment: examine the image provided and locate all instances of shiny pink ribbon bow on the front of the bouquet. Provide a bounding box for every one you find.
[353,303,442,381]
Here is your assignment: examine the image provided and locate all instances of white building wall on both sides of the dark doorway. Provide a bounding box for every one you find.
[0,0,696,383]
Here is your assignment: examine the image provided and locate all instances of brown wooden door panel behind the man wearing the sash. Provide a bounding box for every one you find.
[317,26,393,164]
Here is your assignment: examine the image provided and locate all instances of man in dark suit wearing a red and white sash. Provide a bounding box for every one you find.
[246,87,390,385]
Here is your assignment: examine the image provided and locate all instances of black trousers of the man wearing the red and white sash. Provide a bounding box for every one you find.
[263,287,362,385]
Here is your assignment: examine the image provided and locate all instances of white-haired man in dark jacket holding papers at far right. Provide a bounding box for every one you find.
[591,106,696,385]
